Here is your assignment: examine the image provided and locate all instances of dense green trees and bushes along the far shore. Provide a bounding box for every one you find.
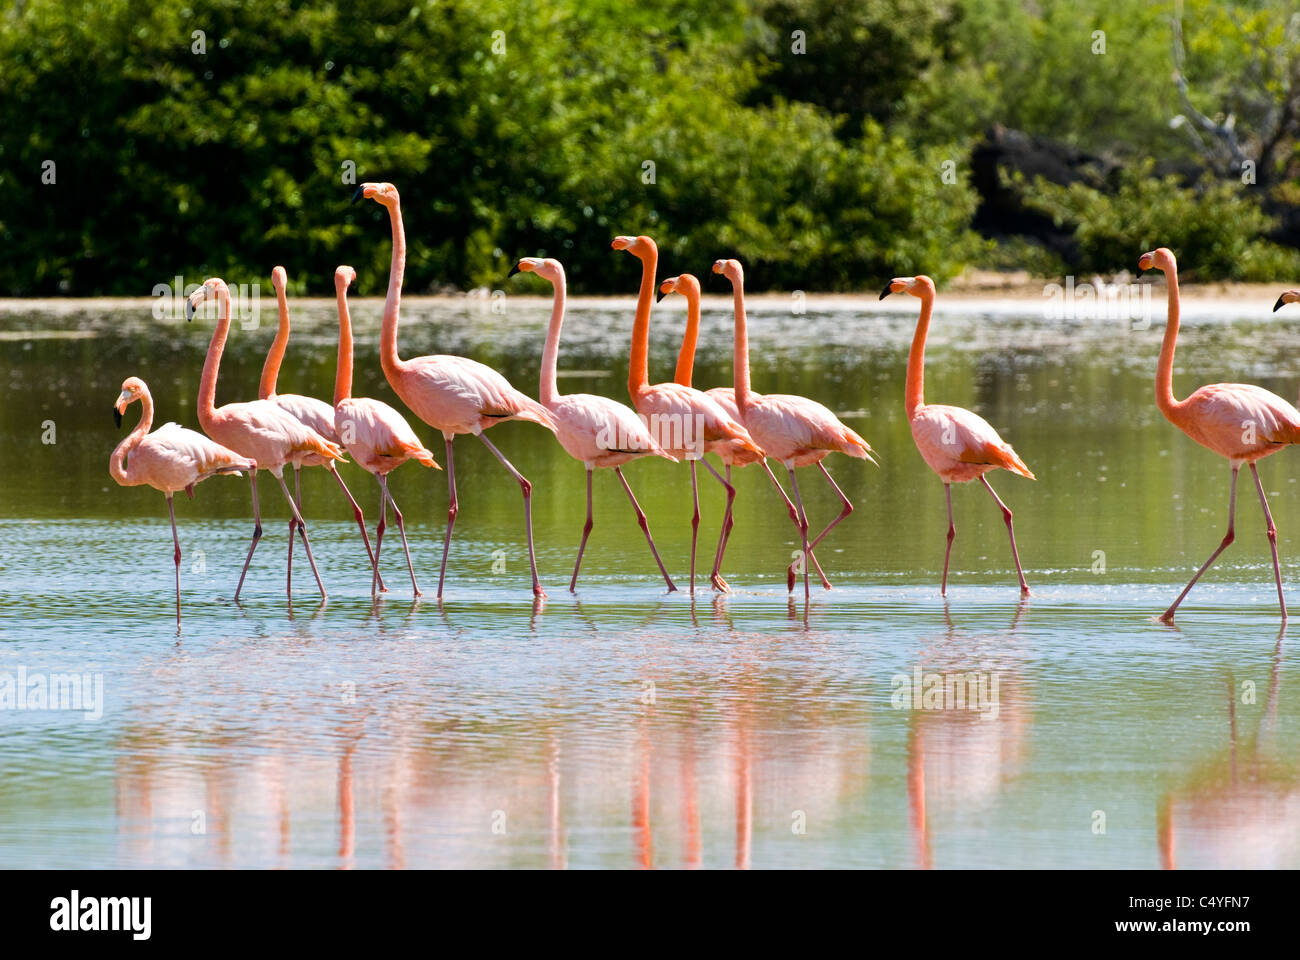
[0,0,1300,295]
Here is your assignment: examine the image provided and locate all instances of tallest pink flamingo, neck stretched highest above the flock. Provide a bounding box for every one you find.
[352,183,556,600]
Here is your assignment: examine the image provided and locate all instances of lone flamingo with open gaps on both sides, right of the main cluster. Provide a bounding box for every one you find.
[880,274,1036,597]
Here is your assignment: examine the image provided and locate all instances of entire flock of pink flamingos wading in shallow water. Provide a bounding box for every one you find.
[109,183,1300,630]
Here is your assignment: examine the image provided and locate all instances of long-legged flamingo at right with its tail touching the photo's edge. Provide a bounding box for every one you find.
[1138,247,1300,624]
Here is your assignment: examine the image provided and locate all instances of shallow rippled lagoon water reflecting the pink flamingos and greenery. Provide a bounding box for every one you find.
[0,298,1300,868]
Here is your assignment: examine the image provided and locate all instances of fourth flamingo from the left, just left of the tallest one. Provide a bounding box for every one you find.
[330,267,442,597]
